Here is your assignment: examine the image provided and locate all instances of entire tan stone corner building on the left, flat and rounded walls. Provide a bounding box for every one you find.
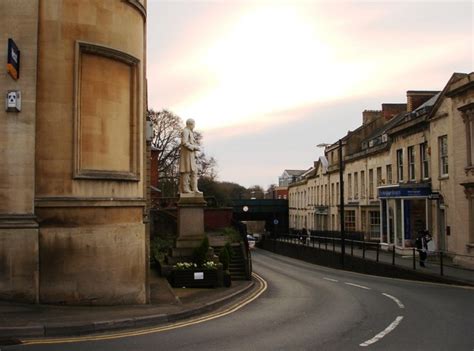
[0,0,147,304]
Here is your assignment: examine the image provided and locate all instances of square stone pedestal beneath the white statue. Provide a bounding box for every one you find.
[168,193,206,264]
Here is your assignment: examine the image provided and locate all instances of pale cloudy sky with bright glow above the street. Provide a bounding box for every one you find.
[147,0,474,189]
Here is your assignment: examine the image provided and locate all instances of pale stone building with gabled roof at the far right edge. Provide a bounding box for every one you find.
[429,73,474,267]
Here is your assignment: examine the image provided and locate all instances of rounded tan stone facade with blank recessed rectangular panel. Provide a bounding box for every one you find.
[0,0,148,304]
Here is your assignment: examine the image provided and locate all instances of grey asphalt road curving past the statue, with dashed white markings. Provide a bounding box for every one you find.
[6,250,474,351]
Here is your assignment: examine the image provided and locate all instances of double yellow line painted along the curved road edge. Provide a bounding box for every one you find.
[21,273,268,345]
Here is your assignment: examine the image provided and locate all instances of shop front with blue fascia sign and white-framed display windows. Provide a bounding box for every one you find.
[378,184,432,250]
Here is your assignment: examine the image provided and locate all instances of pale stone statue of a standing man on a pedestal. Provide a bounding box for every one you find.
[179,119,202,194]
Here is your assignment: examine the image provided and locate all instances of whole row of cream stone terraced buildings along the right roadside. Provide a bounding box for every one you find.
[289,73,474,265]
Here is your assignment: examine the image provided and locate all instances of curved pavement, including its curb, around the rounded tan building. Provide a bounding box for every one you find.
[0,277,255,345]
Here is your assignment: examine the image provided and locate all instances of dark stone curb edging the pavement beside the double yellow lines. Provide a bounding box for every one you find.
[0,279,255,345]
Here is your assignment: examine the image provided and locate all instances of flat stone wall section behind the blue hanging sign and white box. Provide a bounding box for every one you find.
[0,0,38,302]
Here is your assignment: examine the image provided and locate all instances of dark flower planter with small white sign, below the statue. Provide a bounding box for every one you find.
[170,268,222,288]
